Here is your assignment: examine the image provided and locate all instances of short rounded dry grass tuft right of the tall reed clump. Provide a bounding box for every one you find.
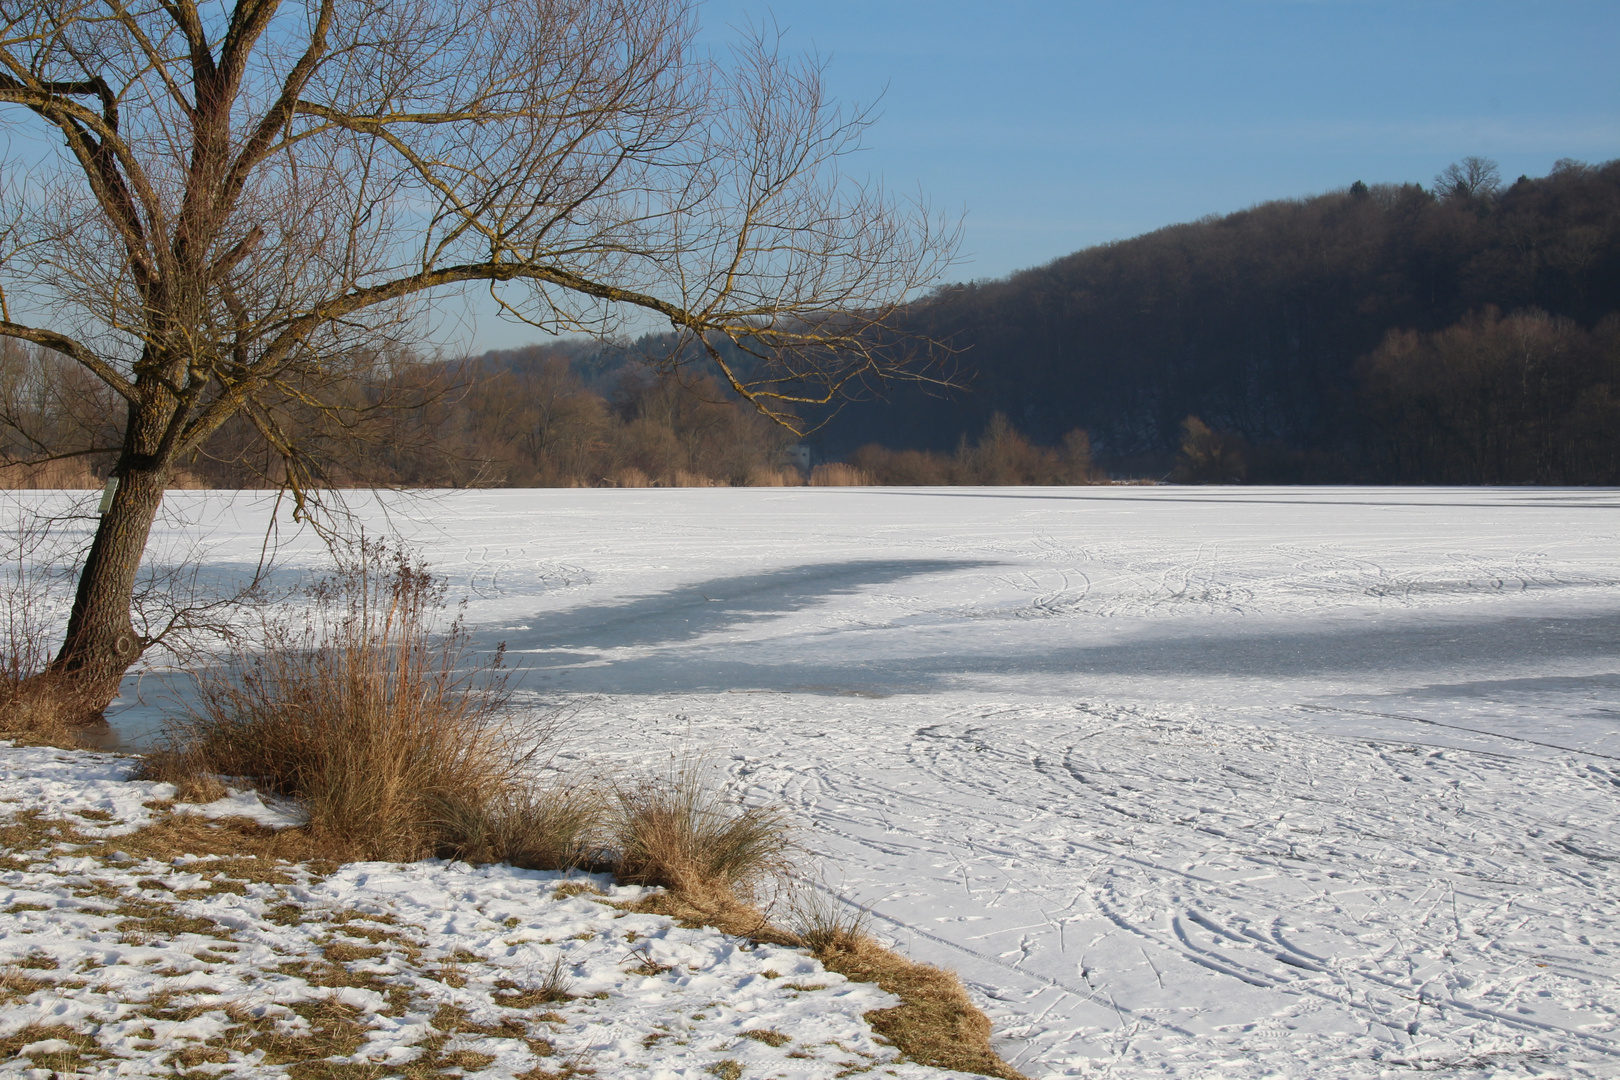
[612,758,799,905]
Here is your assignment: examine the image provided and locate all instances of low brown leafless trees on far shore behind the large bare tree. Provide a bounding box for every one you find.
[0,342,804,487]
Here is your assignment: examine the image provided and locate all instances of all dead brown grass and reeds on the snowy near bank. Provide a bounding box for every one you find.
[0,544,1019,1080]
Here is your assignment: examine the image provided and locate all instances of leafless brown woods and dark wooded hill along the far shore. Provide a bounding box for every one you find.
[0,159,1620,487]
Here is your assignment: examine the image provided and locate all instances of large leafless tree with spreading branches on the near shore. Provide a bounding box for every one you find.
[0,0,954,709]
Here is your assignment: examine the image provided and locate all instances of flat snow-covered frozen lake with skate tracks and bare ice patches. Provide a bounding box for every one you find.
[107,487,1620,1077]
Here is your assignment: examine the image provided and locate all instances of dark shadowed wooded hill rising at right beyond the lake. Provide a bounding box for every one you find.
[825,159,1620,484]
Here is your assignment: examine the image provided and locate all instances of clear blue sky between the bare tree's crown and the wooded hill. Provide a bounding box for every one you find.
[460,0,1620,348]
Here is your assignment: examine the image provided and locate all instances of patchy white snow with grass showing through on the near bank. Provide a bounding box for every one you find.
[0,746,961,1080]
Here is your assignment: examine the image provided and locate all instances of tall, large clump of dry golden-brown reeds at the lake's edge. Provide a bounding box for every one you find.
[144,541,582,860]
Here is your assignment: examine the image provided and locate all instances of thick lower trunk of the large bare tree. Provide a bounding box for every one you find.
[45,453,168,722]
